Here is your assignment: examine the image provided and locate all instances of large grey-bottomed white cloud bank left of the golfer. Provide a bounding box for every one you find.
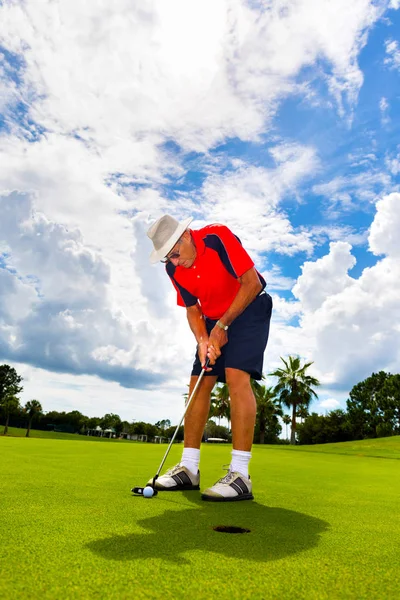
[0,193,195,387]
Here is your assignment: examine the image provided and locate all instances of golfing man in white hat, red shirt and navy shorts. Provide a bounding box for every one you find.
[147,215,272,502]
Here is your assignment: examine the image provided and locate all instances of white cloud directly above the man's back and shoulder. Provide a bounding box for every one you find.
[201,144,318,256]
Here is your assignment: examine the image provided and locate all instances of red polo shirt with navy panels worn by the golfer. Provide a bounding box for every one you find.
[166,224,265,320]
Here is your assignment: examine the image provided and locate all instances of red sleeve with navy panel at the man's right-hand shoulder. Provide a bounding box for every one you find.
[205,225,254,279]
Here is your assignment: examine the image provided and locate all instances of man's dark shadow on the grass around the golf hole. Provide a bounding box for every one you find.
[87,492,329,564]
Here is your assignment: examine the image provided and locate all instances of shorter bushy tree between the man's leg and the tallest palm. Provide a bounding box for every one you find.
[251,380,283,444]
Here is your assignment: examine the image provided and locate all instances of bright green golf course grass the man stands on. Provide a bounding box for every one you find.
[0,436,400,600]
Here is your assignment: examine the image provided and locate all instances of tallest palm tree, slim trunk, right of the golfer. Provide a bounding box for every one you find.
[270,356,320,445]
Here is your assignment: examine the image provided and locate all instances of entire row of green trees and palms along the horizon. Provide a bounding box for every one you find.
[0,356,400,444]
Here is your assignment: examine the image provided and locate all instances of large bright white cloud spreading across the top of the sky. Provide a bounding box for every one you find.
[0,0,385,150]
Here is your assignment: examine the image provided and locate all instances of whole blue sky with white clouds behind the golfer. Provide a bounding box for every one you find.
[0,0,400,423]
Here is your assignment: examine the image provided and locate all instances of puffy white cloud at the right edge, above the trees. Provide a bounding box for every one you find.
[293,194,400,387]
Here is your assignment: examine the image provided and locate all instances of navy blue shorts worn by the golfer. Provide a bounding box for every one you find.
[192,291,272,383]
